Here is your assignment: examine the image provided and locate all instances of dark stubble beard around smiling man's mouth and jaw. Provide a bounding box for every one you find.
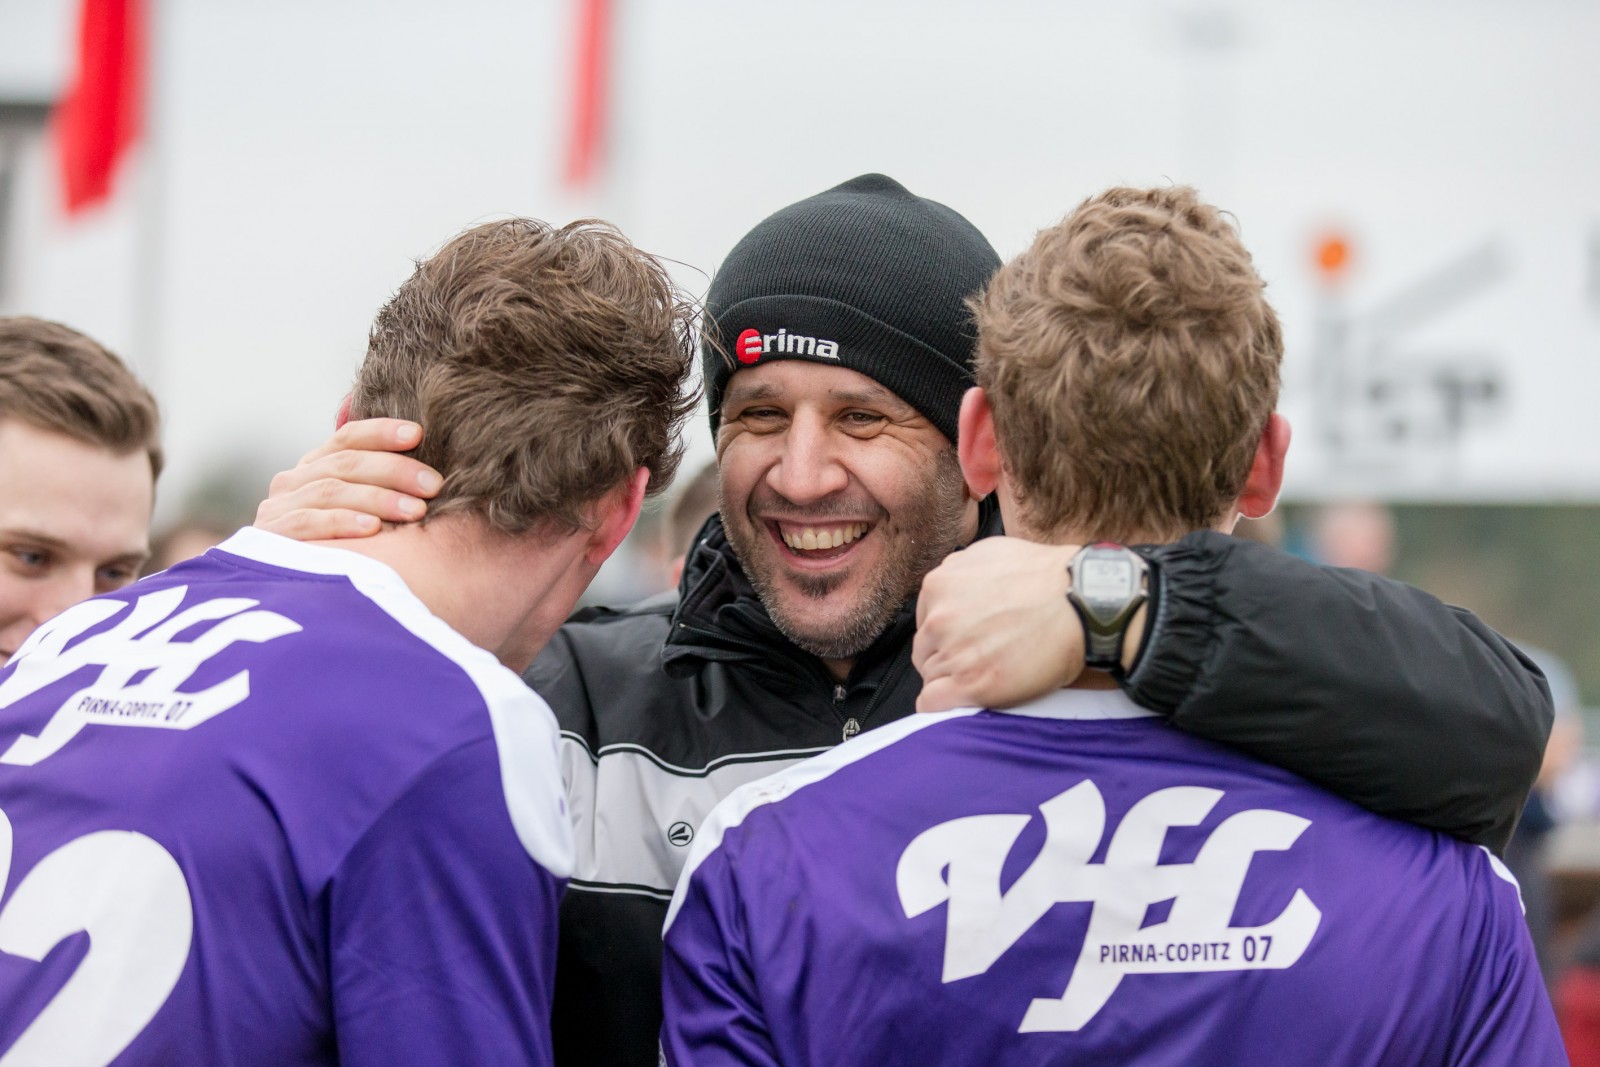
[723,448,966,659]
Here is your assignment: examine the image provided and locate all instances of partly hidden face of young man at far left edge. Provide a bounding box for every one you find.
[0,419,155,665]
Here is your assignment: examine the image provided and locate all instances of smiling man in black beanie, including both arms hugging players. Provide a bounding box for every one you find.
[258,174,1549,1067]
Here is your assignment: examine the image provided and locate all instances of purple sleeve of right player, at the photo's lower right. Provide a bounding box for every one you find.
[1450,856,1566,1067]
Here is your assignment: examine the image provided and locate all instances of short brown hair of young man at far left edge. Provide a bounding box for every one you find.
[0,315,165,480]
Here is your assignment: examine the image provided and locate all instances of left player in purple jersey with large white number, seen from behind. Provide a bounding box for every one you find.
[0,219,694,1067]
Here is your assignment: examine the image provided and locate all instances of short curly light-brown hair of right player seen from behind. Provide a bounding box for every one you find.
[973,186,1283,541]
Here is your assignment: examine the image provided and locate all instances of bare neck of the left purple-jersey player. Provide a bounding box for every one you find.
[308,515,594,672]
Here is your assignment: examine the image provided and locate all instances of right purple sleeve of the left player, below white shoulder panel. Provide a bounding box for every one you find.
[328,739,563,1067]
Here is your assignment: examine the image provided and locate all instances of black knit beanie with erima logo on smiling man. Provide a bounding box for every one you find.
[701,174,1000,442]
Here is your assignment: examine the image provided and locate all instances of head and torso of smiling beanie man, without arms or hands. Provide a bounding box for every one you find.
[540,174,1000,1065]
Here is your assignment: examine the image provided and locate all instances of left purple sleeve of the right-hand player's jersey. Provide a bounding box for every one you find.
[661,849,779,1067]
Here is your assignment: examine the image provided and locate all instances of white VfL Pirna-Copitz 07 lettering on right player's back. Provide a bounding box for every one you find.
[896,781,1322,1033]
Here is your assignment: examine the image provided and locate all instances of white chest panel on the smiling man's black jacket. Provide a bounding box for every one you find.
[562,733,829,901]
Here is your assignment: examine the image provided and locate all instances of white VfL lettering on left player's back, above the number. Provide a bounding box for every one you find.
[0,585,301,766]
